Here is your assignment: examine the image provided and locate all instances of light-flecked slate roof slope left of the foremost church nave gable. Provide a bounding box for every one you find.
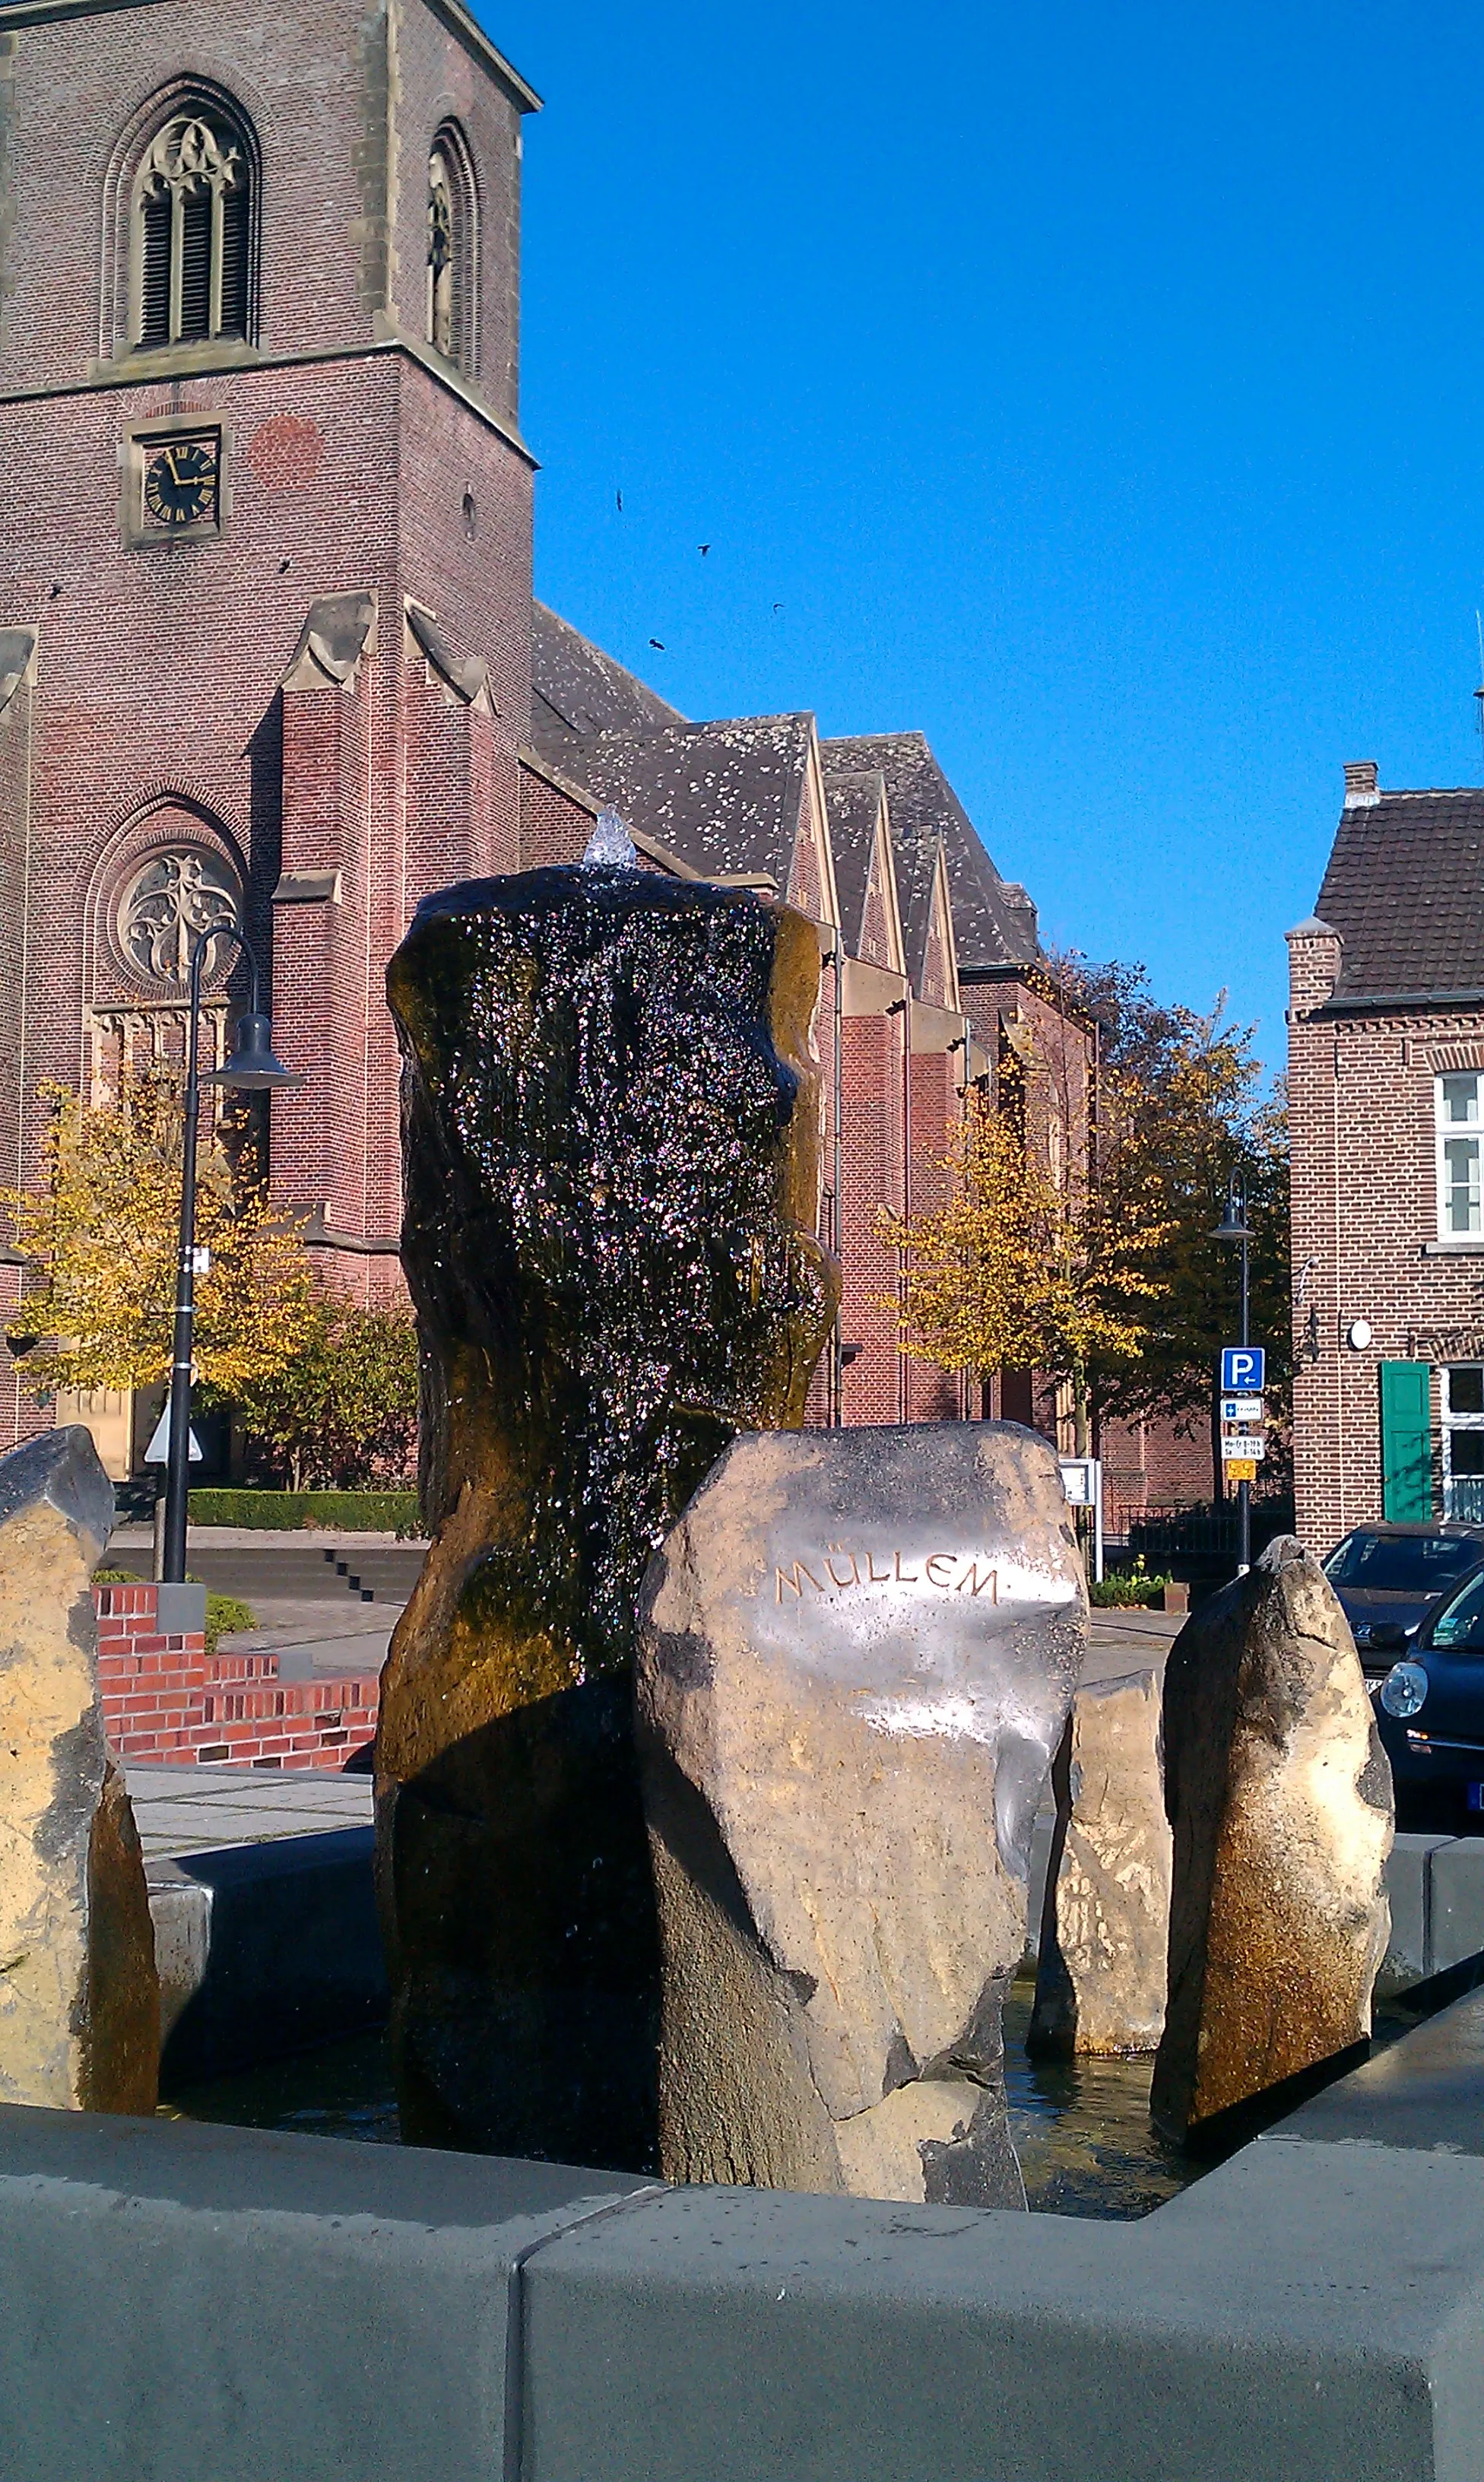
[536,715,814,893]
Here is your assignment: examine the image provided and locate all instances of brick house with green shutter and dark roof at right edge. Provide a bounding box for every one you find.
[1288,762,1484,1549]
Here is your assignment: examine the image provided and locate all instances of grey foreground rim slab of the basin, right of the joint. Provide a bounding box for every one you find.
[521,2147,1484,2482]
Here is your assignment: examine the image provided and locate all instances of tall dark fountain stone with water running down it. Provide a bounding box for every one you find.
[377,868,834,2166]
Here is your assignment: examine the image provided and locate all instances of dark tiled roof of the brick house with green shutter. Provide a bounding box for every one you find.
[1315,787,1484,1000]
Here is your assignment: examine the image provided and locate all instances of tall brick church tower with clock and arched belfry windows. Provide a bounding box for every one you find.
[0,0,536,1445]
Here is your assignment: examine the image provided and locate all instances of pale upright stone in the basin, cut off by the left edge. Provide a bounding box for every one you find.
[0,1427,159,2112]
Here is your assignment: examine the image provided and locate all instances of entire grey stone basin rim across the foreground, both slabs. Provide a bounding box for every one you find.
[0,1993,1484,2482]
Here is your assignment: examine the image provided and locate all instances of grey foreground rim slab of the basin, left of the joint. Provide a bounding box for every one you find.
[0,2107,655,2482]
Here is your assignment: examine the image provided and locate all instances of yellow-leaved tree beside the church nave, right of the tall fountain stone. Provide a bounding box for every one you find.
[881,1087,1172,1457]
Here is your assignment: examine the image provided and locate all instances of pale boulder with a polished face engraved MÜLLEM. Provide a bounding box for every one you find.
[638,1422,1087,2204]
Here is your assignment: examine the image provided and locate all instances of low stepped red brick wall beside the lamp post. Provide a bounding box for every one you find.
[92,1581,379,1767]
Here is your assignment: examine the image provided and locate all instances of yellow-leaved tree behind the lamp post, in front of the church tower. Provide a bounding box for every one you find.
[0,1072,316,1398]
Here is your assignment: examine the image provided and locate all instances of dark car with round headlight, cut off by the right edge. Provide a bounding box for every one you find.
[1372,1569,1484,1827]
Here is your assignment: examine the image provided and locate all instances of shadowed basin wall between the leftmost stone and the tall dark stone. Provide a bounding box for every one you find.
[147,1827,387,2093]
